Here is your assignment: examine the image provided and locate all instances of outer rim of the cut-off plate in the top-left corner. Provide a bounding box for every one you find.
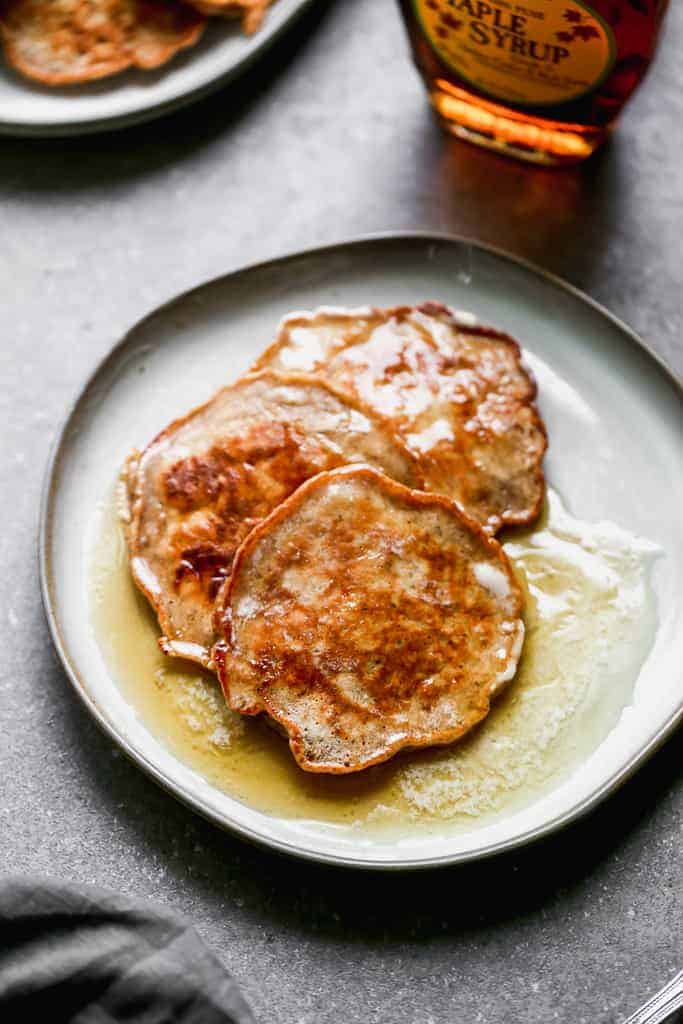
[0,0,315,138]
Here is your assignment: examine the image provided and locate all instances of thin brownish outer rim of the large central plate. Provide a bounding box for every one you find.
[38,234,683,871]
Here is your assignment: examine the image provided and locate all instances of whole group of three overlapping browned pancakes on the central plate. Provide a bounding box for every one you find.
[125,303,547,773]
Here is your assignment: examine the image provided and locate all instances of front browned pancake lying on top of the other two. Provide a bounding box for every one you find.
[214,467,524,774]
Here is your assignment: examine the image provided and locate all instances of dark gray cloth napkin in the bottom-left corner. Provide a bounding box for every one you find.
[0,879,254,1024]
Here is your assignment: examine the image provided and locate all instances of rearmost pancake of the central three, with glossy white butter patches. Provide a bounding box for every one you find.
[254,302,547,534]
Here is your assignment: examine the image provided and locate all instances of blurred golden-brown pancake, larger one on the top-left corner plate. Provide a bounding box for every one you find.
[0,0,206,85]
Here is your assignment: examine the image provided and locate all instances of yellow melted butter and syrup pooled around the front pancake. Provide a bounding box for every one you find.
[91,492,656,833]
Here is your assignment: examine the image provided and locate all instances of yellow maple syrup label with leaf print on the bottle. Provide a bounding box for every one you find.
[413,0,616,106]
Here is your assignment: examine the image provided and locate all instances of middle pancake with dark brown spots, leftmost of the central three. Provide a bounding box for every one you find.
[125,372,421,667]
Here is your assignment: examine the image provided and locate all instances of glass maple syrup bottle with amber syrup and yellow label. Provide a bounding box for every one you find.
[398,0,668,165]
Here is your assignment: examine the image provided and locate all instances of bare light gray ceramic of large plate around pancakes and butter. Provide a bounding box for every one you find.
[41,236,683,868]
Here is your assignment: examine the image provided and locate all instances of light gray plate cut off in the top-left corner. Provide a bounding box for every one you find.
[0,0,313,136]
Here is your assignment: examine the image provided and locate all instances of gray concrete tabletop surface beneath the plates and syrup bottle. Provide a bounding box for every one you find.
[0,0,683,1024]
